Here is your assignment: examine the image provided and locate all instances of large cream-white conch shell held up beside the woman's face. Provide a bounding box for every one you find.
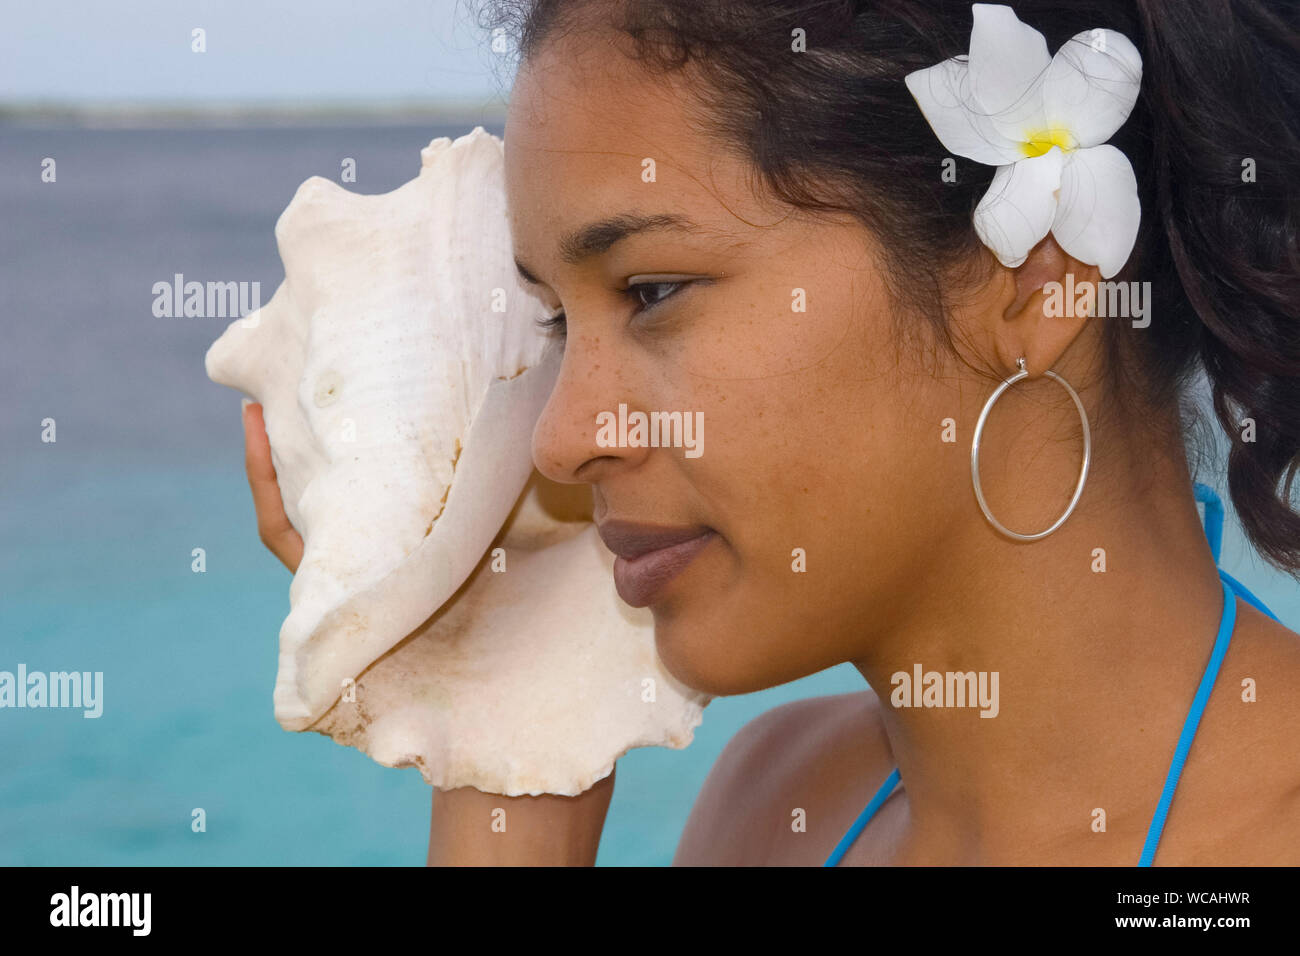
[205,126,709,796]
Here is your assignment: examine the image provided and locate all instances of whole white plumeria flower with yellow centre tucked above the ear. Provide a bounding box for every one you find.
[906,4,1141,278]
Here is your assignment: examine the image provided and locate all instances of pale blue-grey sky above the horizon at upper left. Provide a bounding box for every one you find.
[0,0,512,105]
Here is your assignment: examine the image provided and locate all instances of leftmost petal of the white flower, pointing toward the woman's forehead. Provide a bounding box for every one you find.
[904,60,1024,166]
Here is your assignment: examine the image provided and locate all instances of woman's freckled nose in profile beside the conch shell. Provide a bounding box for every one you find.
[533,333,646,484]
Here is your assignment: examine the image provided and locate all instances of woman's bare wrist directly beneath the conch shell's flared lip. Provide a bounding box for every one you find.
[428,771,614,866]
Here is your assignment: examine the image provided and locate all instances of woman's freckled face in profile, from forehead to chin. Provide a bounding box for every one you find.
[506,31,983,695]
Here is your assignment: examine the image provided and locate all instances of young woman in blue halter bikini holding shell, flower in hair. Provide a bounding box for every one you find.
[247,0,1300,865]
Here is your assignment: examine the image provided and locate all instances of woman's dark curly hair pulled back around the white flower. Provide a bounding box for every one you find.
[467,0,1300,574]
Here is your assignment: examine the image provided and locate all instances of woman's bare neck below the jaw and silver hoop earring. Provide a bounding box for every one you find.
[854,444,1223,862]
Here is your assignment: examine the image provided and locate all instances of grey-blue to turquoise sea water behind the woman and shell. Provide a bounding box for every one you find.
[0,125,1300,865]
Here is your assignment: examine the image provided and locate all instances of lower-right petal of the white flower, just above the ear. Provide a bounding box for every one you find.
[1052,146,1141,278]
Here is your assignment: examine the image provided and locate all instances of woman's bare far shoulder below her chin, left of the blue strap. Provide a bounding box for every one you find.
[673,691,893,866]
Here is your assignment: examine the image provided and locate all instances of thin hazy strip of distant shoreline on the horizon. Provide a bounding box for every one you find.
[0,99,507,129]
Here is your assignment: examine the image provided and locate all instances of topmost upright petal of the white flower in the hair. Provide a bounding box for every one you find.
[970,4,1052,140]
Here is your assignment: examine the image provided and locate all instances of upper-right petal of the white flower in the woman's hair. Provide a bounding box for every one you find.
[1043,30,1141,146]
